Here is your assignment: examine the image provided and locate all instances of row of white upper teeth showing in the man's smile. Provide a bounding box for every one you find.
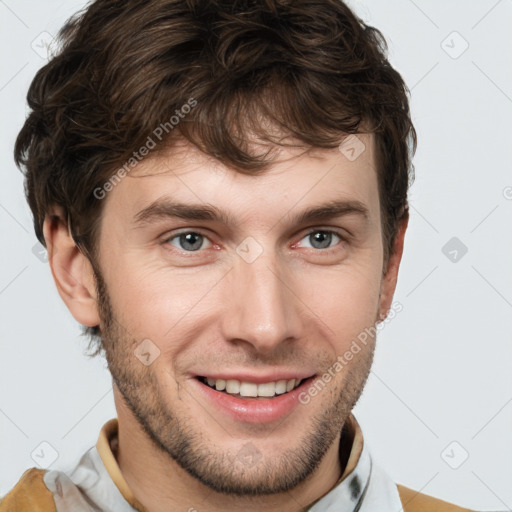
[196,376,306,400]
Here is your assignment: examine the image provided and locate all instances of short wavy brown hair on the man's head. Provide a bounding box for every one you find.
[14,0,416,268]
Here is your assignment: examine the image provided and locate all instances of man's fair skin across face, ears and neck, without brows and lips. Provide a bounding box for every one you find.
[44,134,407,512]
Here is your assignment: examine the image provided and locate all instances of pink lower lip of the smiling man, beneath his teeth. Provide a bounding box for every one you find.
[192,377,314,423]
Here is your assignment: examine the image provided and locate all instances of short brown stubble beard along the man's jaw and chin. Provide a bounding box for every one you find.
[95,269,374,497]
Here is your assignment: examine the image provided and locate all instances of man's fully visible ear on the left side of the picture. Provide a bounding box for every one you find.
[43,206,100,327]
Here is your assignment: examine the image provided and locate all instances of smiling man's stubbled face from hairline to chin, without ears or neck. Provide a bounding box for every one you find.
[93,135,383,494]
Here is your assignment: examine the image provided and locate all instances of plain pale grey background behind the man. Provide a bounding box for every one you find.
[0,0,512,510]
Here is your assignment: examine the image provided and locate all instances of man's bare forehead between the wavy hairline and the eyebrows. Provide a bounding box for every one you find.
[104,134,378,226]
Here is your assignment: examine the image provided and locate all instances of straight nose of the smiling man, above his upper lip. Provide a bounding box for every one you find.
[222,251,304,354]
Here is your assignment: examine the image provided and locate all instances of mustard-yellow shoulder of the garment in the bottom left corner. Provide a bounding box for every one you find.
[0,468,56,512]
